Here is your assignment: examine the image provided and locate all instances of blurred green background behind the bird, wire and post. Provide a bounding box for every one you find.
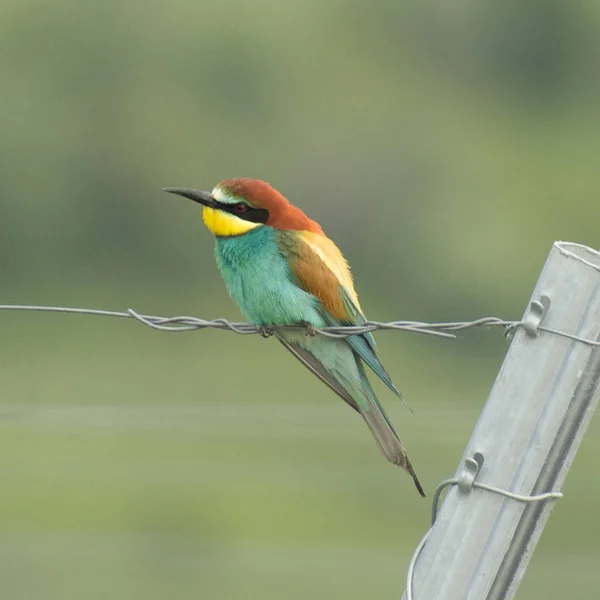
[0,0,600,600]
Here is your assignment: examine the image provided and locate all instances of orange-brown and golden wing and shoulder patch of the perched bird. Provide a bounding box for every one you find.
[290,231,360,322]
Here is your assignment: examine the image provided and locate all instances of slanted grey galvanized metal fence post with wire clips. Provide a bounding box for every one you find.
[404,242,600,600]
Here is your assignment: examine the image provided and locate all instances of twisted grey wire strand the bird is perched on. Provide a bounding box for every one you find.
[0,304,600,346]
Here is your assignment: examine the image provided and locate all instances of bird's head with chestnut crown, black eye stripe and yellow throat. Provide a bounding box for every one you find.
[164,178,323,237]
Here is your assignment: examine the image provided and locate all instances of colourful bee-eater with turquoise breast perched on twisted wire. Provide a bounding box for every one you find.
[165,178,425,496]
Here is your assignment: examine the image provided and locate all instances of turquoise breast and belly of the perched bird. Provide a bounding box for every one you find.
[215,226,325,327]
